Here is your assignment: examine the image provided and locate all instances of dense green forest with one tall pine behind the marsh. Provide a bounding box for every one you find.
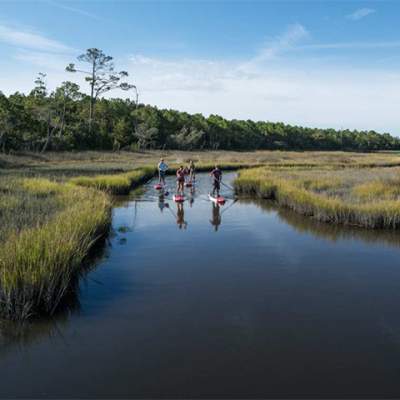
[0,49,400,152]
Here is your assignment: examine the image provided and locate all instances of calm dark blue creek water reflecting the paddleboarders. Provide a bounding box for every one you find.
[0,174,400,398]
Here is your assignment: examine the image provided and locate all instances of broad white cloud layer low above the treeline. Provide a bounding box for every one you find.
[0,25,400,134]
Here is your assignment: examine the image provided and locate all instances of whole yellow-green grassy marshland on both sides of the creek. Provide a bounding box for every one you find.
[0,151,400,320]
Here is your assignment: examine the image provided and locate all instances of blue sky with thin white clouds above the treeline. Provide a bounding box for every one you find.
[0,0,400,136]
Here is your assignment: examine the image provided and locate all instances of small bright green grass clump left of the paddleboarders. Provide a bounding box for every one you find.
[70,167,156,195]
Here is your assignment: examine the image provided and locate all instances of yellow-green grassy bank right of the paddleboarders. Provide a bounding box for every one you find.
[235,167,400,229]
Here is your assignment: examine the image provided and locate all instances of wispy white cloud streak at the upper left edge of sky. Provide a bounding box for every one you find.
[0,25,73,53]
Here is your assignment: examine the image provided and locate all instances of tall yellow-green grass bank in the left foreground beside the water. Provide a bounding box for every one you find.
[0,178,111,319]
